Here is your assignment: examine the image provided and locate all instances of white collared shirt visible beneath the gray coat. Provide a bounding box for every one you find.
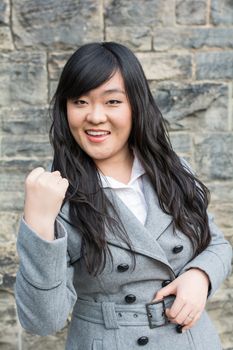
[99,155,147,225]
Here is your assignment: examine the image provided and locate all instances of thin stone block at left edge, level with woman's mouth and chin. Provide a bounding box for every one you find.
[2,135,51,157]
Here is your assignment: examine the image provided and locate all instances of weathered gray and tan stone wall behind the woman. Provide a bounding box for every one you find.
[0,0,233,350]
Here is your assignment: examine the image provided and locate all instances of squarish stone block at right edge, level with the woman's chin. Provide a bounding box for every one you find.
[194,133,233,180]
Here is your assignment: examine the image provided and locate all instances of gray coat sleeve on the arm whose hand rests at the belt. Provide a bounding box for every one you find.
[179,214,232,298]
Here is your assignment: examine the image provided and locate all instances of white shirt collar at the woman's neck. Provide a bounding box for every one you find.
[99,152,145,188]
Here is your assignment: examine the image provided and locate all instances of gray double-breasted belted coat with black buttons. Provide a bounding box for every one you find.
[15,175,232,350]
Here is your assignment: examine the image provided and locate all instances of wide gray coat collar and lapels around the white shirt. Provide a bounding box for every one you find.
[59,174,172,268]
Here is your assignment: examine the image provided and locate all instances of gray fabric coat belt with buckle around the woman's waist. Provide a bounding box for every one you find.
[73,296,175,329]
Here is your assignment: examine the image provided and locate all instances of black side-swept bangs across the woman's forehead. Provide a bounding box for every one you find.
[58,44,119,99]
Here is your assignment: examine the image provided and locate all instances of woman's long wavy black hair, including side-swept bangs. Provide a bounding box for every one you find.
[50,42,211,275]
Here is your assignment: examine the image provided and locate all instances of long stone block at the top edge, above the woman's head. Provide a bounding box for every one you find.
[104,0,175,27]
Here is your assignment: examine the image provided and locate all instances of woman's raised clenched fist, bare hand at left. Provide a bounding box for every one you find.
[24,167,69,240]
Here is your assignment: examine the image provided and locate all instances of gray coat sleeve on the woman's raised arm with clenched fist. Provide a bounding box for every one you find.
[15,219,77,336]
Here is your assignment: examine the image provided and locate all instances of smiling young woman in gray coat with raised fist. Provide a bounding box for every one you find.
[15,42,232,350]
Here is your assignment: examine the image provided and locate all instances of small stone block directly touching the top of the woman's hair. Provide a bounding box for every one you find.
[106,26,152,51]
